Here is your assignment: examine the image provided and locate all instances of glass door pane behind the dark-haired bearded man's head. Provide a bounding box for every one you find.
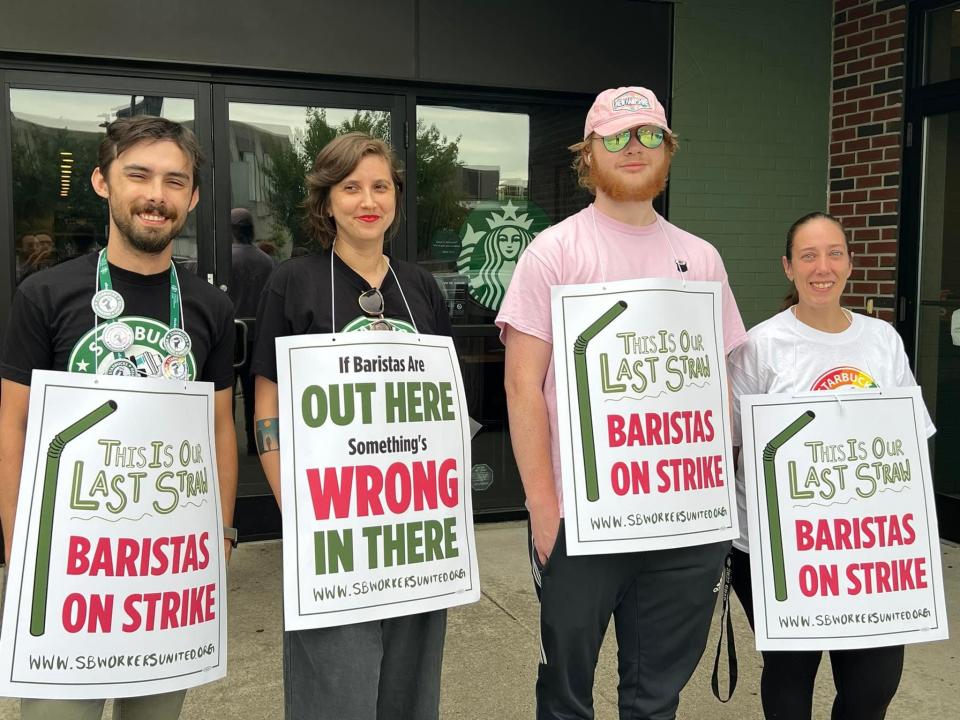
[0,72,213,310]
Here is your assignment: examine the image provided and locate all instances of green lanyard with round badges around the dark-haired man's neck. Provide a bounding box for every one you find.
[90,249,192,380]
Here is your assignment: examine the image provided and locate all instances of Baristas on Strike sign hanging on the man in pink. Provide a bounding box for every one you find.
[552,279,739,555]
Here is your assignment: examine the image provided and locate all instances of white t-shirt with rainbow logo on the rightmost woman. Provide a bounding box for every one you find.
[727,309,936,552]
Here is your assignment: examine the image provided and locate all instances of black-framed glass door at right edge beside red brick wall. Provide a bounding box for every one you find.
[897,0,960,541]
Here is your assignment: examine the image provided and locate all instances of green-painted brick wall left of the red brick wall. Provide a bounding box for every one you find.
[669,0,832,327]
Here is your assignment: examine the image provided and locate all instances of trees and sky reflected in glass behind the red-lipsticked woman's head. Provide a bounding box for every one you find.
[229,102,390,262]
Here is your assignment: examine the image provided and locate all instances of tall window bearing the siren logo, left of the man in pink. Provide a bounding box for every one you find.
[417,104,590,513]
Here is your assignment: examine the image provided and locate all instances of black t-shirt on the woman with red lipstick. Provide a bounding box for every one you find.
[251,250,453,382]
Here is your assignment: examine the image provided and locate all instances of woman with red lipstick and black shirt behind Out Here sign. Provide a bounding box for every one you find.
[252,133,451,720]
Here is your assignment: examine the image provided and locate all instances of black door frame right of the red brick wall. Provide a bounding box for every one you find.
[895,0,960,542]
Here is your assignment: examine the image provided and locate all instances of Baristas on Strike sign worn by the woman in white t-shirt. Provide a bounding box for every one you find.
[741,387,947,650]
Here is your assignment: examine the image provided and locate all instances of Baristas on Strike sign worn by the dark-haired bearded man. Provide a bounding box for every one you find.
[0,371,227,699]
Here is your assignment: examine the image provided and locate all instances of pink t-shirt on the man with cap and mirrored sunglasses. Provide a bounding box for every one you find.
[496,205,747,515]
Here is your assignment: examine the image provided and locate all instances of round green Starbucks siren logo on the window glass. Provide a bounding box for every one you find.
[457,200,550,311]
